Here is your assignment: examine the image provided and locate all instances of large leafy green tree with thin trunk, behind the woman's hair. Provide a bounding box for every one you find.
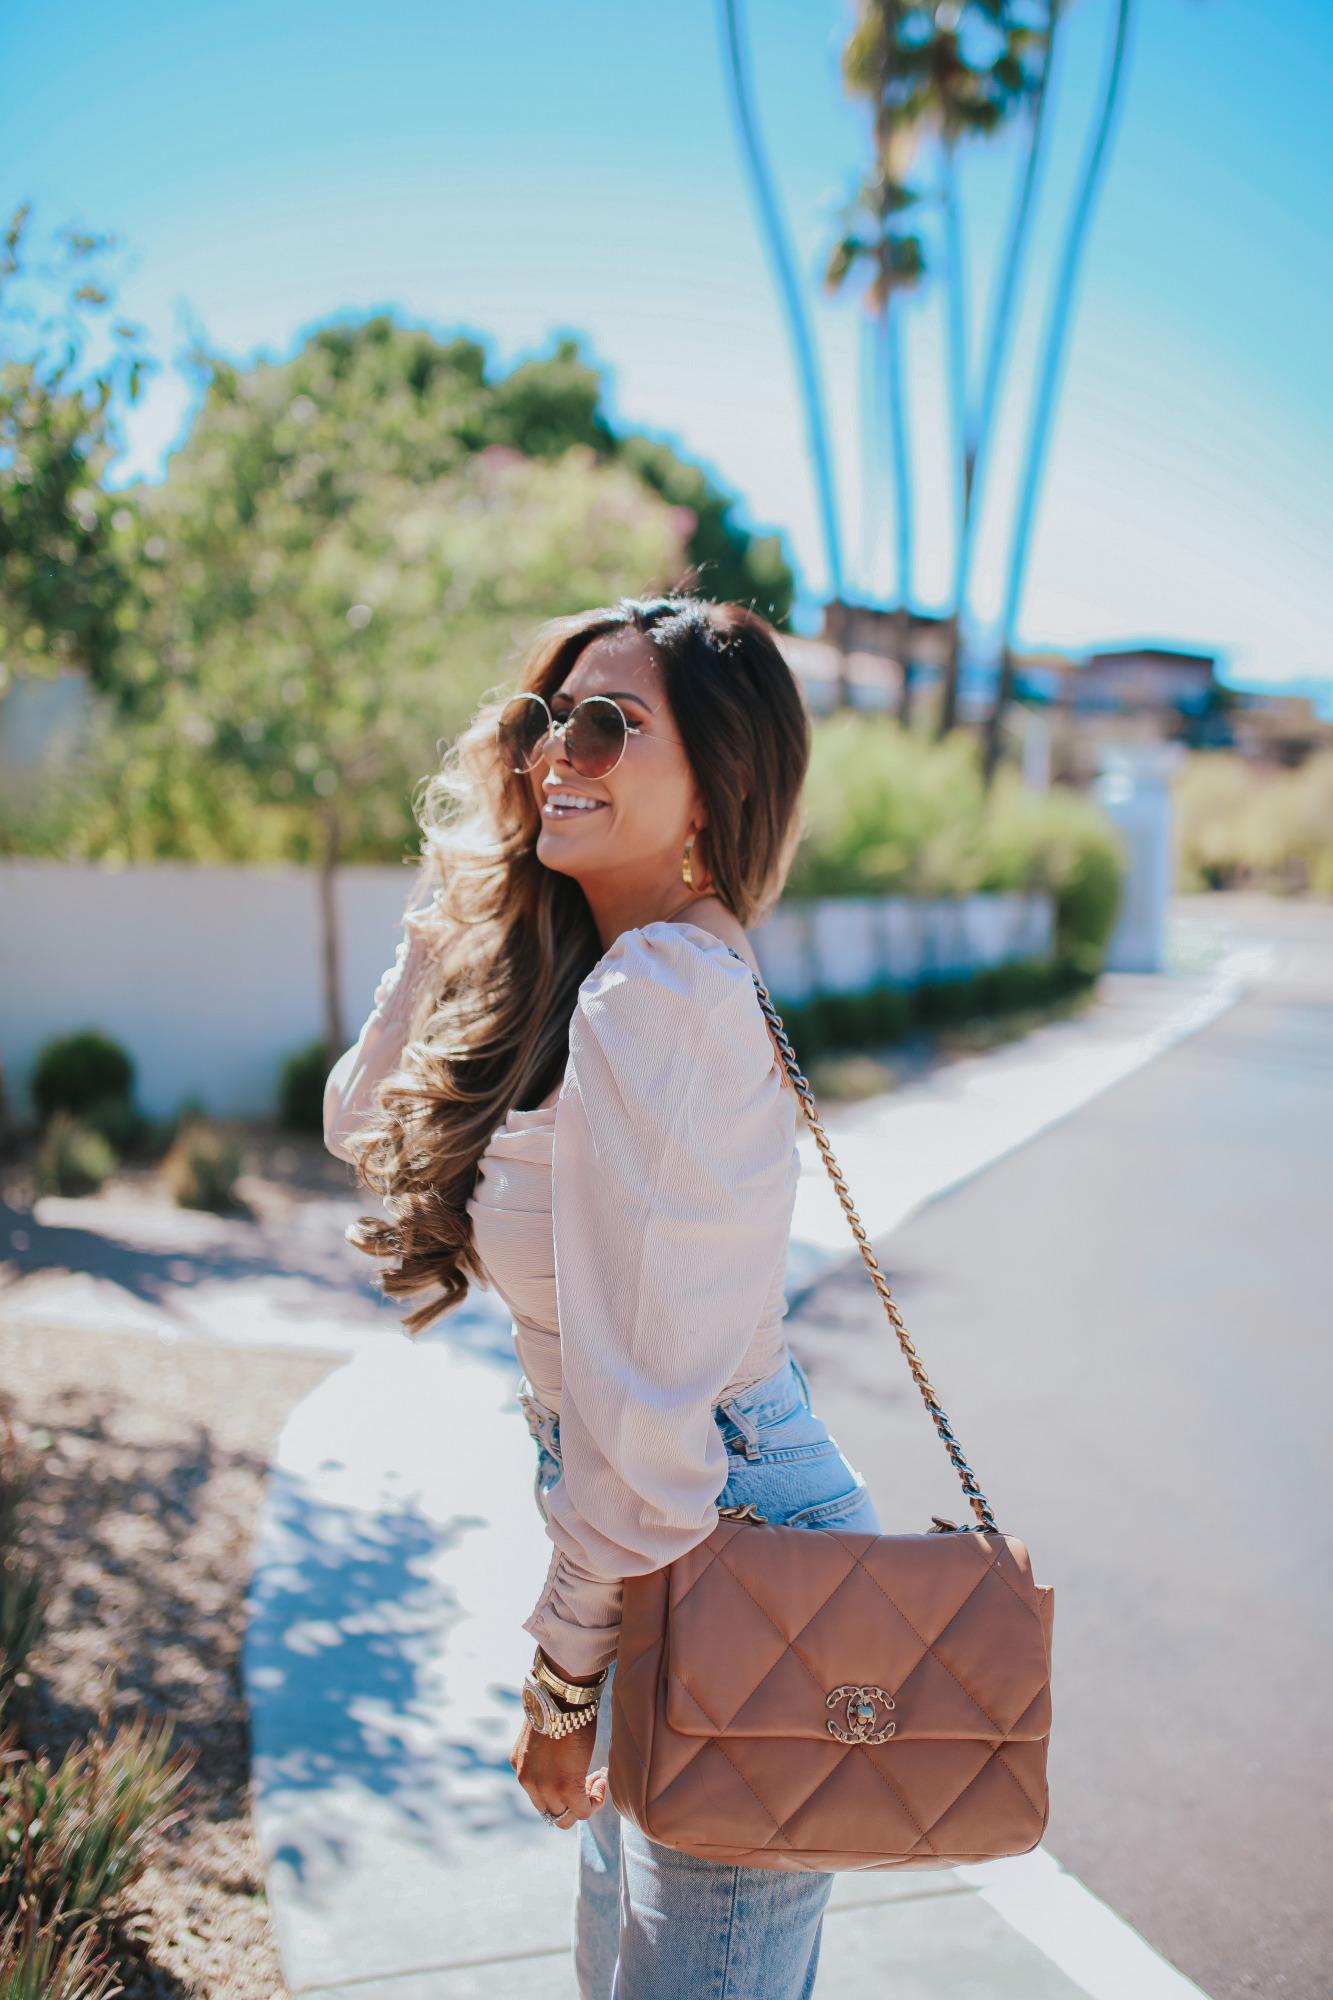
[66,320,736,1048]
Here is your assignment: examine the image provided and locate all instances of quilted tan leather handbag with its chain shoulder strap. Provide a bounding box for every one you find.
[610,980,1053,1870]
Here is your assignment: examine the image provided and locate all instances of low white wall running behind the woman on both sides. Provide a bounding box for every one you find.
[0,862,1053,1118]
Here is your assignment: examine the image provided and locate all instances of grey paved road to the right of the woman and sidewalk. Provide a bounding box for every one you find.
[789,906,1333,2000]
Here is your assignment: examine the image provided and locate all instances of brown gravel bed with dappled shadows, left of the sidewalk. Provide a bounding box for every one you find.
[0,1324,336,2000]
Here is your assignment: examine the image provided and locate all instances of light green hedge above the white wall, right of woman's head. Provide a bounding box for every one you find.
[789,712,1123,972]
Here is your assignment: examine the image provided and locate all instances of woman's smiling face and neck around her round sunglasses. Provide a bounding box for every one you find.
[528,632,707,908]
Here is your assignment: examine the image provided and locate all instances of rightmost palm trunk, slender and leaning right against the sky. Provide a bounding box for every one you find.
[985,0,1133,780]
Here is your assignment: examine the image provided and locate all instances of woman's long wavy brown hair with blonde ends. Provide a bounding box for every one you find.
[348,596,809,1332]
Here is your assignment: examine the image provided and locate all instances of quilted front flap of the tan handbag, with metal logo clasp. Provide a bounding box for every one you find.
[667,1522,1051,1742]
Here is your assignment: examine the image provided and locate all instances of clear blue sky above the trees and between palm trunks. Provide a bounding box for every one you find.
[0,0,1333,684]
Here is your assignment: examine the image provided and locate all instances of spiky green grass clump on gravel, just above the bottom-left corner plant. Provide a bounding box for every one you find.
[0,1722,190,1926]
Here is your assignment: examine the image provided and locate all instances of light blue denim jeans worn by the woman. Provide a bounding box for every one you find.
[524,1362,879,2000]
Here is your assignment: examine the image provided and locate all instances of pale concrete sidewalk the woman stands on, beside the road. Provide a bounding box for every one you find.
[244,952,1259,2000]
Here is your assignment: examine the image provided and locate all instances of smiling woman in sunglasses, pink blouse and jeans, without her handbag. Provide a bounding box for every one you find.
[326,598,877,2000]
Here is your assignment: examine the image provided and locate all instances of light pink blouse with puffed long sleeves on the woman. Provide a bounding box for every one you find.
[326,924,797,1674]
